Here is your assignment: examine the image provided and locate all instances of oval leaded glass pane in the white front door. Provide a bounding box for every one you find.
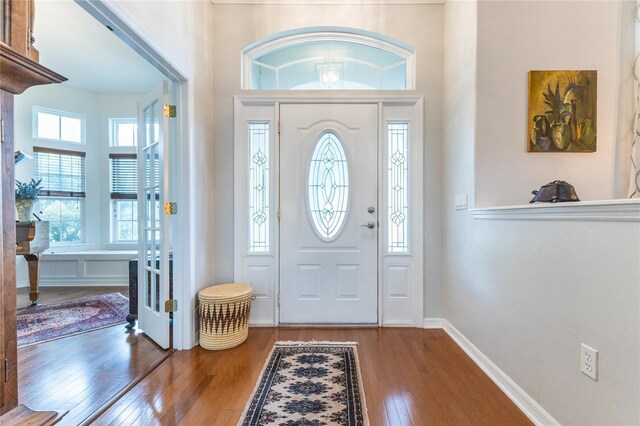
[307,130,349,241]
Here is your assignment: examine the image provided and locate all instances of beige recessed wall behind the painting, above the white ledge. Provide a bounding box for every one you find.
[475,1,635,207]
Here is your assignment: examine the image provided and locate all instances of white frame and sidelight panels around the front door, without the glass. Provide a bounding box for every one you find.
[234,91,424,327]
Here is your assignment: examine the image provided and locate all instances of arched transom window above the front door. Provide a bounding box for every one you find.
[242,27,415,90]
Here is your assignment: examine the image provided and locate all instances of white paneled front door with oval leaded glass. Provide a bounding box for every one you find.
[280,104,378,324]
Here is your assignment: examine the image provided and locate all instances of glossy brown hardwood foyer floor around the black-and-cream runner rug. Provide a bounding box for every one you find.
[94,328,531,426]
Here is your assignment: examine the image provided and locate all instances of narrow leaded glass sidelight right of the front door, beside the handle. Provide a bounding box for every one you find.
[387,122,409,253]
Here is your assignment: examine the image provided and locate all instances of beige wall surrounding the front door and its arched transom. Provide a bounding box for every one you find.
[211,4,443,316]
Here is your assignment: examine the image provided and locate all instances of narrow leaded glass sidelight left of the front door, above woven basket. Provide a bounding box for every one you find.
[249,123,270,253]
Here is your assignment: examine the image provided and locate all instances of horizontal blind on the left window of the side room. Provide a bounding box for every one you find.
[33,146,86,198]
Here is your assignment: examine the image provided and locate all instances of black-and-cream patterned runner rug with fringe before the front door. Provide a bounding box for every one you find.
[238,342,369,426]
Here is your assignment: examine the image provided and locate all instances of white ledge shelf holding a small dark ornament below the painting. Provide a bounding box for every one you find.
[470,199,640,222]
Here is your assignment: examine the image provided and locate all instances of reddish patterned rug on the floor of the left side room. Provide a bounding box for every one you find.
[17,293,129,347]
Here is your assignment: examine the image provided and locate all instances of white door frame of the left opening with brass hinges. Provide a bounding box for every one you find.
[74,0,192,349]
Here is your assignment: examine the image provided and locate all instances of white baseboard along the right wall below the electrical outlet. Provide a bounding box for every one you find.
[424,318,560,425]
